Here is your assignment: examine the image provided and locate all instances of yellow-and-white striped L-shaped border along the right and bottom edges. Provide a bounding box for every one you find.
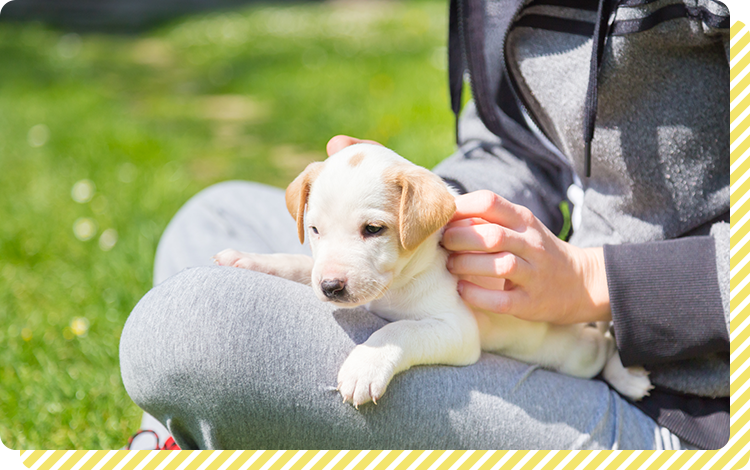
[14,13,750,470]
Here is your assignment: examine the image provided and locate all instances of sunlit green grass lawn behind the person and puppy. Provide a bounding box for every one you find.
[0,0,453,451]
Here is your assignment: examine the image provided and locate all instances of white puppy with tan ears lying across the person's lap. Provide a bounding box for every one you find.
[215,144,650,407]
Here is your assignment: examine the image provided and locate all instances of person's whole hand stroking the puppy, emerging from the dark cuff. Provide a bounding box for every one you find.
[442,191,611,324]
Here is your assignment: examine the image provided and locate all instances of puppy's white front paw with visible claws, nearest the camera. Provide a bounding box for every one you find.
[337,345,394,408]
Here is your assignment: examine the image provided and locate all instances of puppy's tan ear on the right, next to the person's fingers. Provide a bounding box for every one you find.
[386,165,456,251]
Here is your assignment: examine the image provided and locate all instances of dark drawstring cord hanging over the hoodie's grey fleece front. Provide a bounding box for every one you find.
[583,0,619,177]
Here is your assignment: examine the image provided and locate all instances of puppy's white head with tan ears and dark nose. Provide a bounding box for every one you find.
[286,144,456,307]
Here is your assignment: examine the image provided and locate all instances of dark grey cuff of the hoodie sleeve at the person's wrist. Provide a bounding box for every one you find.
[604,222,729,366]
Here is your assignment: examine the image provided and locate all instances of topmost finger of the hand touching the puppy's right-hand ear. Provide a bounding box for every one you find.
[451,190,534,228]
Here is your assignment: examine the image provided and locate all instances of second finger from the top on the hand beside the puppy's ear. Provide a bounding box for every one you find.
[442,224,526,257]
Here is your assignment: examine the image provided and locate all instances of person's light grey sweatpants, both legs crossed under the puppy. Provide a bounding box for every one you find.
[120,177,680,449]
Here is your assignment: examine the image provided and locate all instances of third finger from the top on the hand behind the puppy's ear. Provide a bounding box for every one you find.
[448,252,531,284]
